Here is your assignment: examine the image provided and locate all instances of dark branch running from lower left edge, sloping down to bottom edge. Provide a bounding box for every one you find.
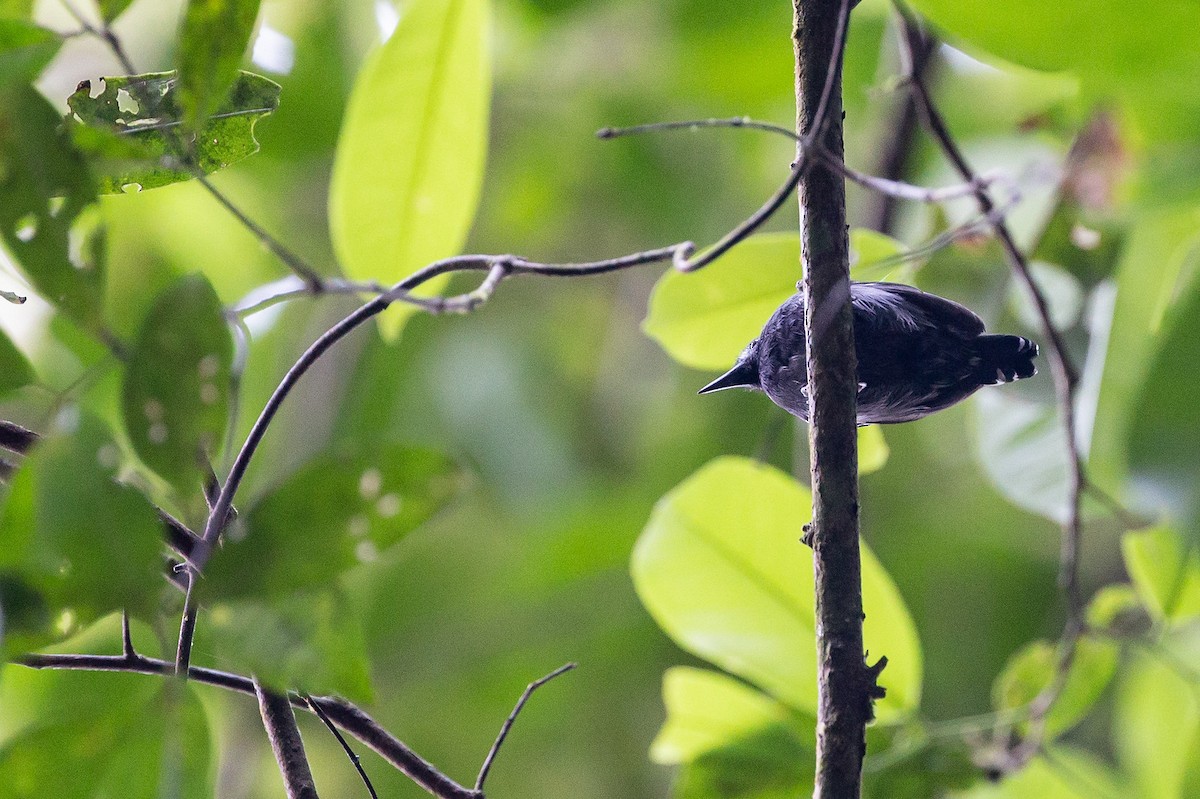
[16,651,481,799]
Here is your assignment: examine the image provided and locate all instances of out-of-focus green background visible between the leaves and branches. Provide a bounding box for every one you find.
[0,0,1195,798]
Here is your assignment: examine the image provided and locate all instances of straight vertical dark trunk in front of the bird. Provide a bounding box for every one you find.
[793,0,877,799]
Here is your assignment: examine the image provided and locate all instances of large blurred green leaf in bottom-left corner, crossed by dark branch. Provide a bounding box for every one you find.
[0,615,215,799]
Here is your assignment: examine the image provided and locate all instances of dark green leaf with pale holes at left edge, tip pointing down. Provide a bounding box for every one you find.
[0,84,104,330]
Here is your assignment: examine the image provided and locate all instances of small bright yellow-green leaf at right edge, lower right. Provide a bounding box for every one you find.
[1121,527,1200,621]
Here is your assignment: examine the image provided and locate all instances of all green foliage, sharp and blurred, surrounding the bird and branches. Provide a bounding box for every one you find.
[0,0,1200,799]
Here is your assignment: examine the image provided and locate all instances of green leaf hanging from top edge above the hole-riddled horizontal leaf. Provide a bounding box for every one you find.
[178,0,259,131]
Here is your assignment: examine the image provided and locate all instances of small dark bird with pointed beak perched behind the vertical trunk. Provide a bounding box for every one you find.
[700,283,1038,425]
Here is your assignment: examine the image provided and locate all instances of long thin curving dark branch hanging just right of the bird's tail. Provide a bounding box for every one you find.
[896,2,1087,771]
